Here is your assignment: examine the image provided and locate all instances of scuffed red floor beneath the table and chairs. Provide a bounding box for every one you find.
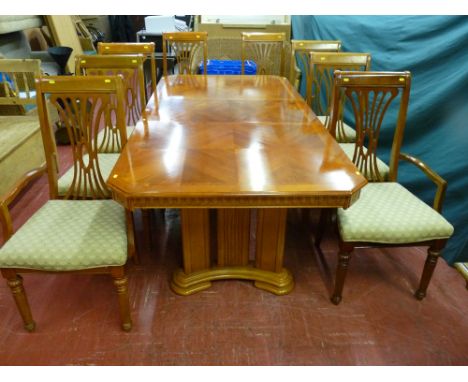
[0,145,468,365]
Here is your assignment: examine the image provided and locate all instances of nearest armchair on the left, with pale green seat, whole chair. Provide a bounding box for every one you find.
[0,76,134,331]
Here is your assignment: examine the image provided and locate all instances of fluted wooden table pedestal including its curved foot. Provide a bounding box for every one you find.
[171,208,294,295]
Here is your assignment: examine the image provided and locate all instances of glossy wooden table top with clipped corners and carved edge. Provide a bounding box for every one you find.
[108,75,366,209]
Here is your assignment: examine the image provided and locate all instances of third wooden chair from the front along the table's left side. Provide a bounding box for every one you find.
[98,42,157,101]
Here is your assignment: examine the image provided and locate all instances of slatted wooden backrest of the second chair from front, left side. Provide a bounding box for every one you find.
[75,55,146,153]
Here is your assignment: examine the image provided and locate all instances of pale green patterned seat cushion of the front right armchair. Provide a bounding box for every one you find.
[338,182,453,244]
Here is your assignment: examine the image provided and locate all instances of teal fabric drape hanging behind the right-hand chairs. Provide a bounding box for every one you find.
[292,16,468,264]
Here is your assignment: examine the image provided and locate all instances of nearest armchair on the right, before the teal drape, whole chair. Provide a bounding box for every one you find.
[316,70,453,304]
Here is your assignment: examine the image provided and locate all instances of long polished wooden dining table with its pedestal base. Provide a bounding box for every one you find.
[107,75,367,295]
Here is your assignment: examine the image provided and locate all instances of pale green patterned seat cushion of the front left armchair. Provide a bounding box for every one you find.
[0,200,127,271]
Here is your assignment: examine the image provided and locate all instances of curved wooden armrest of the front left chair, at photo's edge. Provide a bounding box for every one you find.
[0,164,46,243]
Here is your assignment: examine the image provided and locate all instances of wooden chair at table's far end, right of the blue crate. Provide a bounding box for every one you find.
[241,32,286,76]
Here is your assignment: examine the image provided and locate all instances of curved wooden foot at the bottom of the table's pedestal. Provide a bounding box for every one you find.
[171,266,294,296]
